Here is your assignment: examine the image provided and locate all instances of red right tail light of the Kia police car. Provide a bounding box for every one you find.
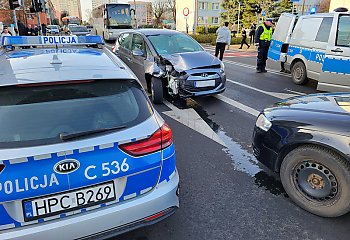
[119,124,173,157]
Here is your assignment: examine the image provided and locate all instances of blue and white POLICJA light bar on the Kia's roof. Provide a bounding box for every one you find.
[2,36,104,46]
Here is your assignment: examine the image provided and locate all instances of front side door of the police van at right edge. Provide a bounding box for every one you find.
[318,14,350,91]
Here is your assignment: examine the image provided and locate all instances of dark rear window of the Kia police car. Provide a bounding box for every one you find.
[0,80,152,148]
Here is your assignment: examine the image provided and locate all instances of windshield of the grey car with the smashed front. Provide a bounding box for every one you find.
[148,33,203,55]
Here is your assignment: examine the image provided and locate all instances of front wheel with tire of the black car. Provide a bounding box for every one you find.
[280,145,350,217]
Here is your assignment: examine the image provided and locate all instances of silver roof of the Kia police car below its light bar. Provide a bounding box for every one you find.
[0,47,134,86]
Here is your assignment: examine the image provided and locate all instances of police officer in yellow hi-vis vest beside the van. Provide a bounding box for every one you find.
[255,18,273,73]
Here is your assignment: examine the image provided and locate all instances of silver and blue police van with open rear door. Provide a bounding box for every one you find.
[268,9,350,91]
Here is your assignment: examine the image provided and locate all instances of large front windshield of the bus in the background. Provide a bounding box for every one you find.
[107,4,131,28]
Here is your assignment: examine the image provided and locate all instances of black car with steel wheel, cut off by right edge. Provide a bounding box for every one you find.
[253,93,350,217]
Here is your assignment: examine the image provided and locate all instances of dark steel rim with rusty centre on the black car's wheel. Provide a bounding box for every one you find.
[294,161,338,201]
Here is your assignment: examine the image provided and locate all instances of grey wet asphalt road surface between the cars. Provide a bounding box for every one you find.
[108,47,350,240]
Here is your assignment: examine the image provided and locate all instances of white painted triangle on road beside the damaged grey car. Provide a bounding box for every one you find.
[163,101,226,147]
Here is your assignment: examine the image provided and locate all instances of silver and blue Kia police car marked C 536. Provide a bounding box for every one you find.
[0,36,179,240]
